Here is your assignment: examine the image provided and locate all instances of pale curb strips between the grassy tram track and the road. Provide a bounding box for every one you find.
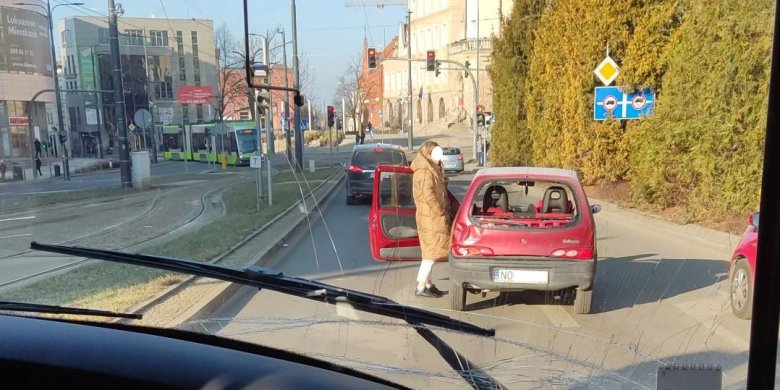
[115,170,344,327]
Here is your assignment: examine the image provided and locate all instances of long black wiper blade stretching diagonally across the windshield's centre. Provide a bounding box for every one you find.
[30,242,496,337]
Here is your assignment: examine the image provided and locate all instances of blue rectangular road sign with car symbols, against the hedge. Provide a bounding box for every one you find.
[593,87,655,121]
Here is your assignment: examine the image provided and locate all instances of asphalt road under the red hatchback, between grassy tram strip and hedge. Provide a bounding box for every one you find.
[204,171,750,389]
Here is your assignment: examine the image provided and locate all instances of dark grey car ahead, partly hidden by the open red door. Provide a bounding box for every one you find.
[346,144,407,205]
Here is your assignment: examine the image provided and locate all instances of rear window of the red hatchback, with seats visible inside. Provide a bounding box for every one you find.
[469,180,578,228]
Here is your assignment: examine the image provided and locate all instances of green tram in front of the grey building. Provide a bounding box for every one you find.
[162,121,259,165]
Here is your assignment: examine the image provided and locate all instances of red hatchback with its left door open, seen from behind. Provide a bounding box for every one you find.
[369,167,600,313]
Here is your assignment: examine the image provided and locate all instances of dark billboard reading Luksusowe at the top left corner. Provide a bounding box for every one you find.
[0,7,52,76]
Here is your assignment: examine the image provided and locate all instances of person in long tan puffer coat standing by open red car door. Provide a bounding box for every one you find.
[411,141,451,298]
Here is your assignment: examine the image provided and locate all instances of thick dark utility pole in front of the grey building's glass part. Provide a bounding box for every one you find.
[108,0,132,188]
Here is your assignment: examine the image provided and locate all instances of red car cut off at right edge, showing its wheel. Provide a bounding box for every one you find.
[729,212,759,319]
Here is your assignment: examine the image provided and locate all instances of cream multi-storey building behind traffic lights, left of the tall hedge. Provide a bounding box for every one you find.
[384,0,513,131]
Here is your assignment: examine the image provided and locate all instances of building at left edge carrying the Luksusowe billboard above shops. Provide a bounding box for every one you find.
[0,0,55,161]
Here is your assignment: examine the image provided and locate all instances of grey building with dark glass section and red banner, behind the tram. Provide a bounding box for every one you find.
[58,16,220,156]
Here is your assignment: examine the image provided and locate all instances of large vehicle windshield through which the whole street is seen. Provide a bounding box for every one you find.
[0,0,780,389]
